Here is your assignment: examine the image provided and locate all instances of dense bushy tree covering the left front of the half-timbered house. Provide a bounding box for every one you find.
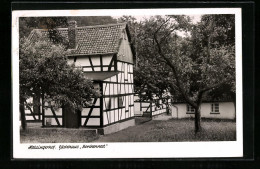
[19,36,99,129]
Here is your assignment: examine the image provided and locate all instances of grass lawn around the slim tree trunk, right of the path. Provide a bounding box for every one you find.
[94,119,236,142]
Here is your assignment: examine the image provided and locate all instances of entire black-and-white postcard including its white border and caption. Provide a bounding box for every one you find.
[12,8,243,158]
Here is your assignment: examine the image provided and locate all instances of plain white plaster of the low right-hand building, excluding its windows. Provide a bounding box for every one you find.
[171,102,235,119]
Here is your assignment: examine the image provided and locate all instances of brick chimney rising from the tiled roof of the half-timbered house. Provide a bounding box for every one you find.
[68,21,77,49]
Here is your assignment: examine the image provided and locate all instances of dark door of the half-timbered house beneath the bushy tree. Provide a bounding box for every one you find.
[63,105,81,128]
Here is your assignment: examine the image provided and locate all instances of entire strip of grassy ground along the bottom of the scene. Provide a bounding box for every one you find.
[21,118,236,143]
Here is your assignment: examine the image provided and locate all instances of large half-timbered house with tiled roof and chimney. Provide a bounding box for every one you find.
[27,21,134,132]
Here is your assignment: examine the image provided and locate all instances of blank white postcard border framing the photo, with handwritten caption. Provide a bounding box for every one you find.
[12,8,243,159]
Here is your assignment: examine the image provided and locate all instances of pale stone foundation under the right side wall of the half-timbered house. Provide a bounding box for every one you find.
[97,119,135,135]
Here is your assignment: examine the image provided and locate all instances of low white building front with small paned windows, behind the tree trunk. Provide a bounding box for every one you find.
[171,101,236,120]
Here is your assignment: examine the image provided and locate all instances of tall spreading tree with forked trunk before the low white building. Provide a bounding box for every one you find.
[133,15,235,132]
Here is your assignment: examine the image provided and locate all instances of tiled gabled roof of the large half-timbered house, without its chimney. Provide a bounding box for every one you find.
[28,23,128,55]
